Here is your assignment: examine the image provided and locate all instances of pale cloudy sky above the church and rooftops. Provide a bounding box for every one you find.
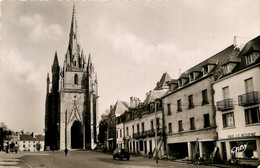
[0,0,260,133]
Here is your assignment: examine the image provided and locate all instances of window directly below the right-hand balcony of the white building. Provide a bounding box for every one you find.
[245,107,260,125]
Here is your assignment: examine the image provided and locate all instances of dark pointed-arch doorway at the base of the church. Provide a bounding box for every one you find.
[71,121,83,149]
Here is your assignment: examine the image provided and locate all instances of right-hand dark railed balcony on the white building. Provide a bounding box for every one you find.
[238,91,259,106]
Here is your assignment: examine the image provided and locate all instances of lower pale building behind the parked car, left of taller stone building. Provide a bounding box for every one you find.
[116,73,170,157]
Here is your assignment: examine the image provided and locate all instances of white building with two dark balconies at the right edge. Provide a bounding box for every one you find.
[213,36,260,165]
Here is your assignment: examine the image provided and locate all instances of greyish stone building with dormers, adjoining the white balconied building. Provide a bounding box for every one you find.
[162,45,239,160]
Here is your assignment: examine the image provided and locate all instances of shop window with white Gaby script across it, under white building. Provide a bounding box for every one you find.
[230,140,258,159]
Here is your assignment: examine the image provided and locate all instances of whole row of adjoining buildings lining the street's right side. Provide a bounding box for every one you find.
[99,36,260,164]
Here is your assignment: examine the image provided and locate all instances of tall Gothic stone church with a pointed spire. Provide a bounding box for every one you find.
[45,5,98,150]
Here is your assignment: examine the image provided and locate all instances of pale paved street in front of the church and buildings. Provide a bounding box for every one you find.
[0,151,250,168]
